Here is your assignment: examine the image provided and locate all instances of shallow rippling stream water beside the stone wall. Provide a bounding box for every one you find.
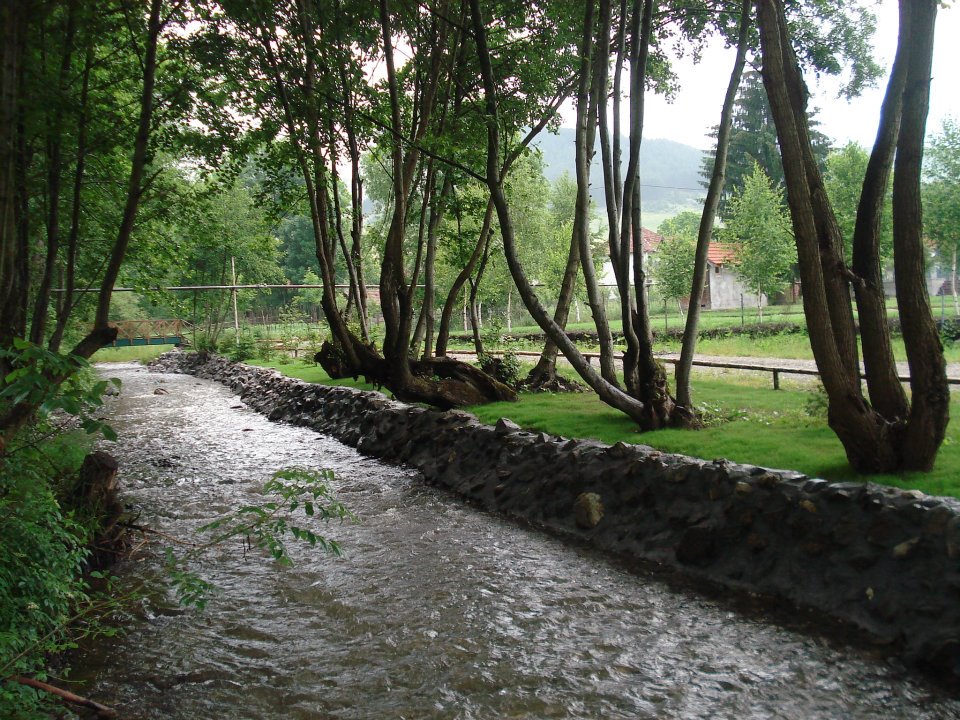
[73,365,960,720]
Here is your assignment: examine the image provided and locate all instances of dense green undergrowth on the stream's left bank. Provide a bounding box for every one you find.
[0,339,120,718]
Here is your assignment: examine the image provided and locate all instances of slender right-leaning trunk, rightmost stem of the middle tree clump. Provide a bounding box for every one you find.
[675,0,752,415]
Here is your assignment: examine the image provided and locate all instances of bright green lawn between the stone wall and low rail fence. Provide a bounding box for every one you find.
[256,362,960,497]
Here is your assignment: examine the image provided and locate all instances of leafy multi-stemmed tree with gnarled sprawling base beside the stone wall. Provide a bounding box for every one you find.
[206,0,514,407]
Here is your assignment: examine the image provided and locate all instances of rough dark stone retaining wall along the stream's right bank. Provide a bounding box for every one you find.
[151,351,960,680]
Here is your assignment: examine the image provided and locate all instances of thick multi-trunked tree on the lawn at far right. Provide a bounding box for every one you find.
[756,0,949,472]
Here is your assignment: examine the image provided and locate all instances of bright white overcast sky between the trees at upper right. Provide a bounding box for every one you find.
[584,0,960,149]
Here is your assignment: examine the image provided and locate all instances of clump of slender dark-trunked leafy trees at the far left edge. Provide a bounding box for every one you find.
[0,0,174,452]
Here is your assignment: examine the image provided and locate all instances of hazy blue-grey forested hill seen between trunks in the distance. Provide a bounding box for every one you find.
[535,128,705,212]
